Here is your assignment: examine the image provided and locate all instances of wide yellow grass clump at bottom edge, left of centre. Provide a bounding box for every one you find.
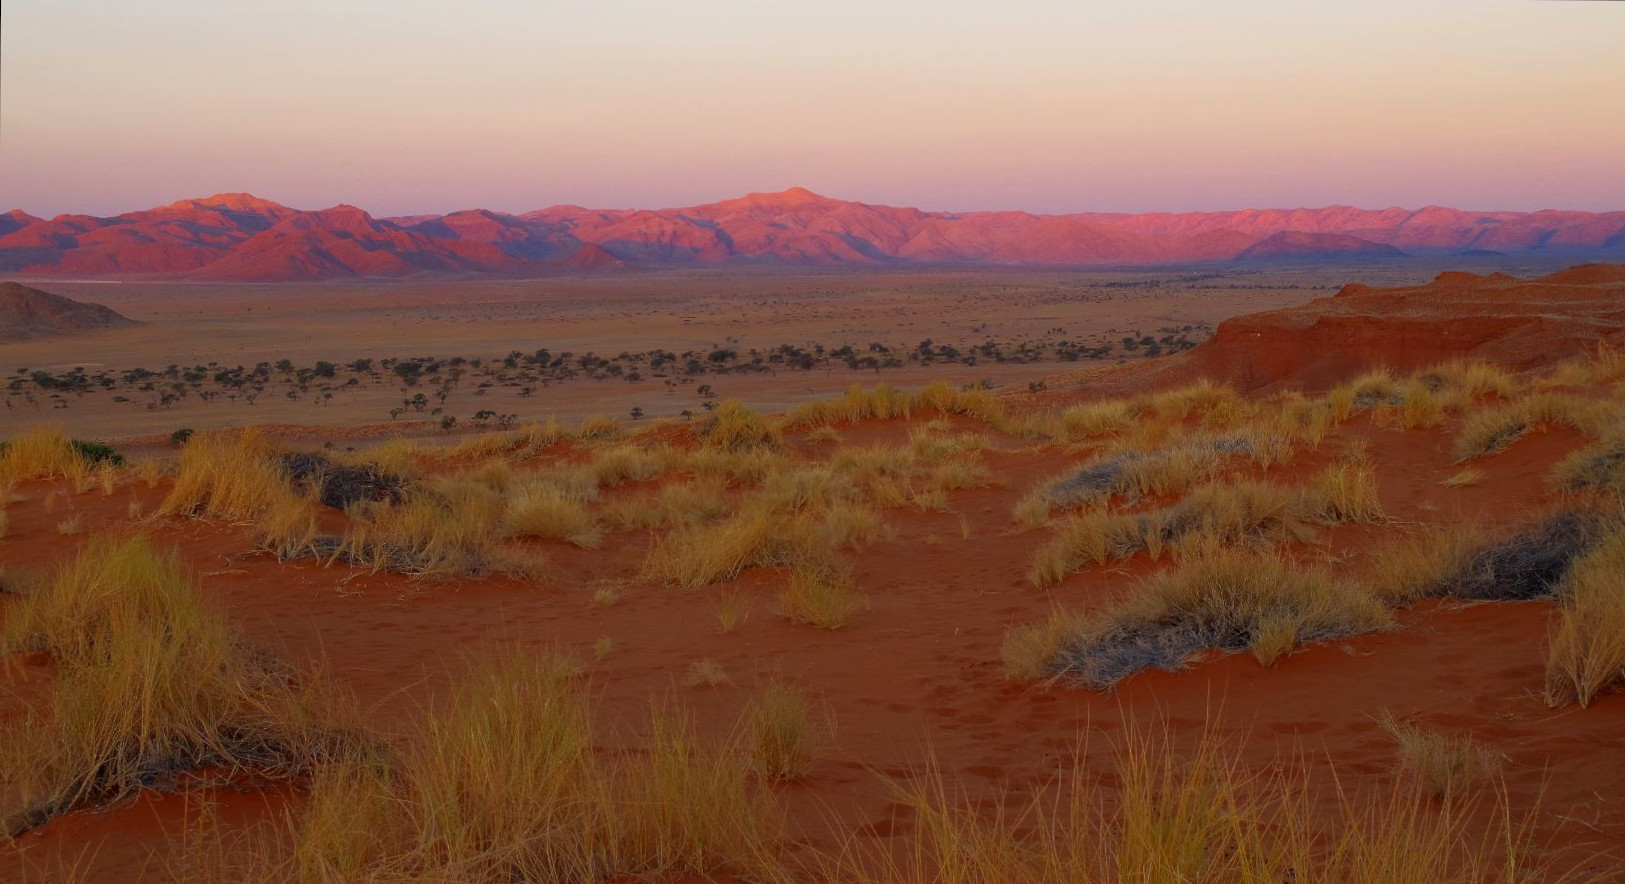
[269,650,783,884]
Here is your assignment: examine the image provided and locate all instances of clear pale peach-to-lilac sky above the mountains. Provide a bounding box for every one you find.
[0,0,1625,216]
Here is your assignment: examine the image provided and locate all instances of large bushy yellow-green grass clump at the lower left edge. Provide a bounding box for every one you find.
[0,538,364,835]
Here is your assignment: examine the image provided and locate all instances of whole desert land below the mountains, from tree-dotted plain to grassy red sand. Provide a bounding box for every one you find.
[0,257,1625,884]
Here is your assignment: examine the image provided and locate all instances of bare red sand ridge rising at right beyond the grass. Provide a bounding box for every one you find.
[1108,258,1625,392]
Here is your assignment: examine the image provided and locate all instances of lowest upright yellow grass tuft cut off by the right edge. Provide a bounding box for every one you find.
[1545,528,1625,705]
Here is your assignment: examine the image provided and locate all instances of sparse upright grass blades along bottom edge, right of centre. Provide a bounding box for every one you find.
[804,731,1540,884]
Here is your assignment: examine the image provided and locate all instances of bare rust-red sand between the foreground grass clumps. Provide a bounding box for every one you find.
[0,411,1625,881]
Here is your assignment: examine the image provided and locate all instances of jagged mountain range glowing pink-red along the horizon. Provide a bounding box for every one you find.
[0,187,1625,283]
